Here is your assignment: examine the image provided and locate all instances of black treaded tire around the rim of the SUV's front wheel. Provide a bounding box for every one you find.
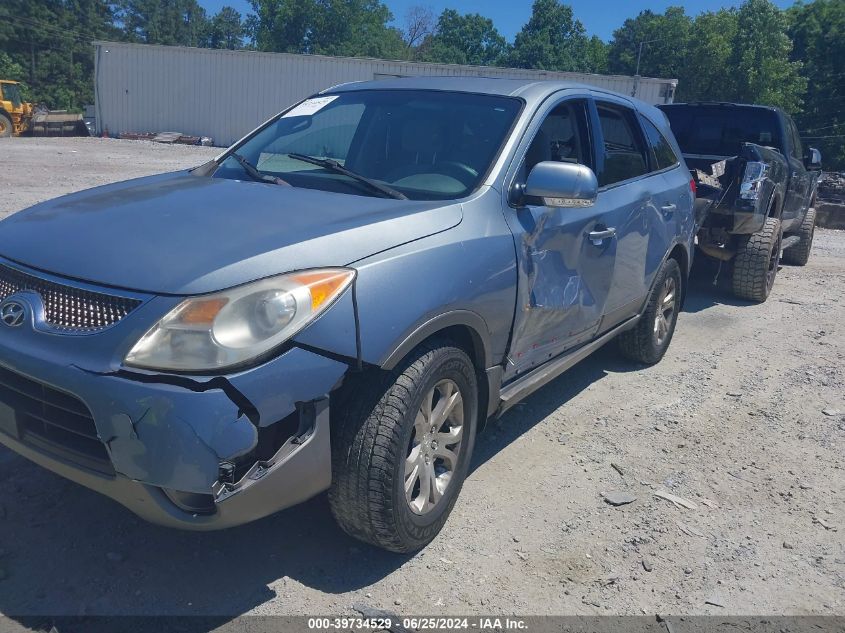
[329,341,479,552]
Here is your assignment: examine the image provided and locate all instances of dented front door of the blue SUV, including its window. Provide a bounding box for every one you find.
[504,94,616,380]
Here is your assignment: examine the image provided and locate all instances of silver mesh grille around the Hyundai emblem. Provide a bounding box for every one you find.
[0,264,141,333]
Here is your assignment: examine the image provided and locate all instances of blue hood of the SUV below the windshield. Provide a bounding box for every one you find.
[0,172,461,295]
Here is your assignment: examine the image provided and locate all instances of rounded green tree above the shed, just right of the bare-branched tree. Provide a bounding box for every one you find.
[422,9,508,66]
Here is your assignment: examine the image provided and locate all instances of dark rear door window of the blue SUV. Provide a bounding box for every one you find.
[596,103,648,187]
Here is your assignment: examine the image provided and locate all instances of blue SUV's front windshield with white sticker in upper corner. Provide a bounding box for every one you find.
[214,90,522,200]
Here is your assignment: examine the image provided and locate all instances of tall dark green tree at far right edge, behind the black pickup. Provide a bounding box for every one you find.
[787,0,845,171]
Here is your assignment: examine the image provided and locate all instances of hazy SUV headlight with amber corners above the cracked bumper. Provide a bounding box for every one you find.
[124,268,355,371]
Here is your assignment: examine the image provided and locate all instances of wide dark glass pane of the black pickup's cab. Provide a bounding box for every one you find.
[662,105,781,156]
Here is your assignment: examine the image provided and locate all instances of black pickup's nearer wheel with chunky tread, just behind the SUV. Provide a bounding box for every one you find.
[732,218,783,303]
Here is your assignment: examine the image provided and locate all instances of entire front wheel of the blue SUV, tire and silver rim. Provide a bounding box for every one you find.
[329,341,479,552]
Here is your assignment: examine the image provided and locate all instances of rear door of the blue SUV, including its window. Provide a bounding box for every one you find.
[594,97,672,332]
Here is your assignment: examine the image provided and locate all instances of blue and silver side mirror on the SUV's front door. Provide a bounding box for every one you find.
[522,161,599,207]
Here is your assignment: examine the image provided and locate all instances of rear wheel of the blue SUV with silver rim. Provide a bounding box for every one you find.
[617,259,683,365]
